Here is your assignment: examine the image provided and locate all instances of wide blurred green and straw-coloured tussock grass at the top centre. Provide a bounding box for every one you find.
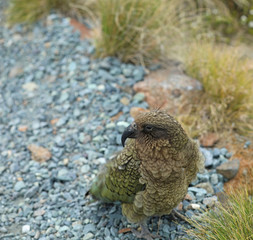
[95,0,217,64]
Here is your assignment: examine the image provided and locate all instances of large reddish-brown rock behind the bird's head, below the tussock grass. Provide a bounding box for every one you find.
[134,67,202,115]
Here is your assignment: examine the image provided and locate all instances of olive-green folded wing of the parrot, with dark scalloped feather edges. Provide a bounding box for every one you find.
[89,139,143,203]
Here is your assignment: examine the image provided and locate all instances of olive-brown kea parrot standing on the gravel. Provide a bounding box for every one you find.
[88,109,204,240]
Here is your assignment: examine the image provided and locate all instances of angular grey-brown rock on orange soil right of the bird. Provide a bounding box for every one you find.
[216,159,240,180]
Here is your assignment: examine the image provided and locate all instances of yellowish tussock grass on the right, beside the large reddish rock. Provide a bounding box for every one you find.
[180,42,253,135]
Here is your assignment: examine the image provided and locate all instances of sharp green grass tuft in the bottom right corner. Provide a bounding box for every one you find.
[187,189,253,240]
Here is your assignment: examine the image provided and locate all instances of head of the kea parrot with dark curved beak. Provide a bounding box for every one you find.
[121,110,187,146]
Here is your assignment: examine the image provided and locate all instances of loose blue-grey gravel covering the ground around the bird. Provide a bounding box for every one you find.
[0,8,245,240]
